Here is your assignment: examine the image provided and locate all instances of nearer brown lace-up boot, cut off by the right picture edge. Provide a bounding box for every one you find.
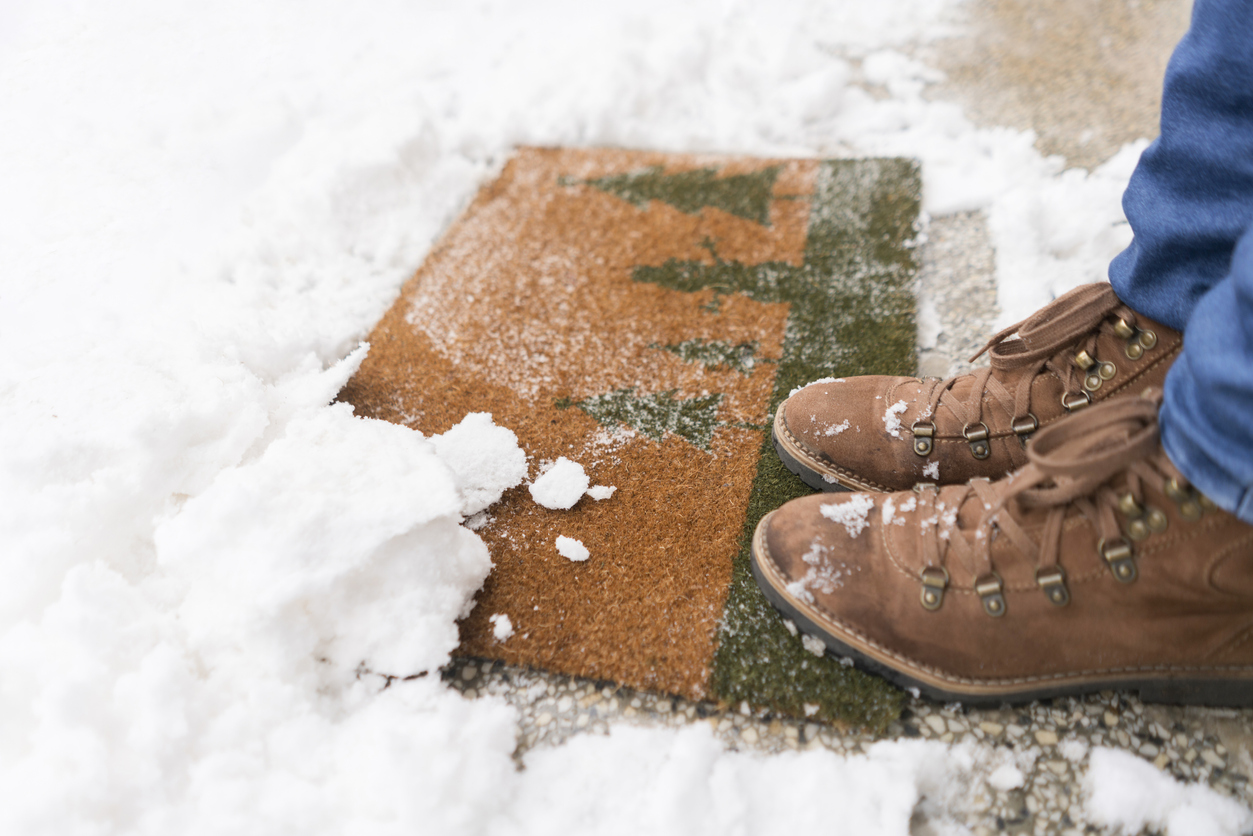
[752,397,1253,706]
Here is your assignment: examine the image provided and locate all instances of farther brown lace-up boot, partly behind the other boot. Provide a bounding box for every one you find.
[774,283,1183,491]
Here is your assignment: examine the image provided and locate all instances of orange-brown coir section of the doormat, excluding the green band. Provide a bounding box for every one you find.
[341,148,912,721]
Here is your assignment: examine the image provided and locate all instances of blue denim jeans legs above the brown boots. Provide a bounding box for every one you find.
[1109,0,1253,523]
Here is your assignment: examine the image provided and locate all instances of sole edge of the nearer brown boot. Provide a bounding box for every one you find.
[751,514,1253,708]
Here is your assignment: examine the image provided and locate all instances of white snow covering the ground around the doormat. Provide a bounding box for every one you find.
[0,0,1250,836]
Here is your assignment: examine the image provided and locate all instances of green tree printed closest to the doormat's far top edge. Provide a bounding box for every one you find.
[559,165,779,227]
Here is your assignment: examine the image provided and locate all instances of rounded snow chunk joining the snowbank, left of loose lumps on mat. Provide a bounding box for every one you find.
[431,412,526,516]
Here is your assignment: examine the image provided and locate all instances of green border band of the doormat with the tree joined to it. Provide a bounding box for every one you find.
[633,159,920,729]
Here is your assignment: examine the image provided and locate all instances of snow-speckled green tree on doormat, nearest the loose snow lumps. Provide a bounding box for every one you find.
[556,389,722,450]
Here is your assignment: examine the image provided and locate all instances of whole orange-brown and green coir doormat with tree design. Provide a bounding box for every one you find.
[341,148,920,728]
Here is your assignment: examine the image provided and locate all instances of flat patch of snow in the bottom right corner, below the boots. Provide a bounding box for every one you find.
[1084,747,1253,836]
